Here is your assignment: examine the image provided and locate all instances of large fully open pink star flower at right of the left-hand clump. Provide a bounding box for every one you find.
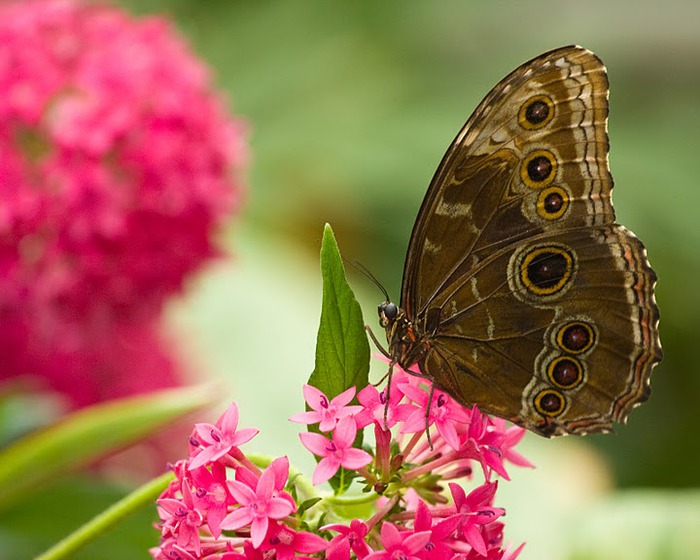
[221,466,294,548]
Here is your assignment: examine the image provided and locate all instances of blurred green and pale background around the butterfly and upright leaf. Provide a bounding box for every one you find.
[5,0,700,559]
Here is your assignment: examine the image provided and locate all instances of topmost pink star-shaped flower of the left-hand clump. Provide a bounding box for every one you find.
[189,403,258,469]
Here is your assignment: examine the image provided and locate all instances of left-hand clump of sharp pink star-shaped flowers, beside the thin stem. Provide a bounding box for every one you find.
[151,403,327,560]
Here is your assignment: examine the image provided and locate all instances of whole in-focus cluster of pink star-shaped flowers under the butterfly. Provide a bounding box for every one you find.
[151,370,531,560]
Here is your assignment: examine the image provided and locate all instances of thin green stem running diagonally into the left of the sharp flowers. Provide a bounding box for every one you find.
[35,472,174,560]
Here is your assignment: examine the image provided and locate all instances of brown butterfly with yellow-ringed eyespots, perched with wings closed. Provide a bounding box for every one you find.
[379,46,662,437]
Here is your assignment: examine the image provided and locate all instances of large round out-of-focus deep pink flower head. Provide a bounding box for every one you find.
[0,0,245,404]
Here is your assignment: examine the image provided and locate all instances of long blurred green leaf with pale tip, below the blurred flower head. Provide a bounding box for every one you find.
[0,386,214,508]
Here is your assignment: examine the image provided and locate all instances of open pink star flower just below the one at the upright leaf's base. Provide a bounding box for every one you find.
[299,416,372,484]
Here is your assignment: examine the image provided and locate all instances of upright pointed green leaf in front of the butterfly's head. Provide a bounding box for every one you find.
[309,224,369,399]
